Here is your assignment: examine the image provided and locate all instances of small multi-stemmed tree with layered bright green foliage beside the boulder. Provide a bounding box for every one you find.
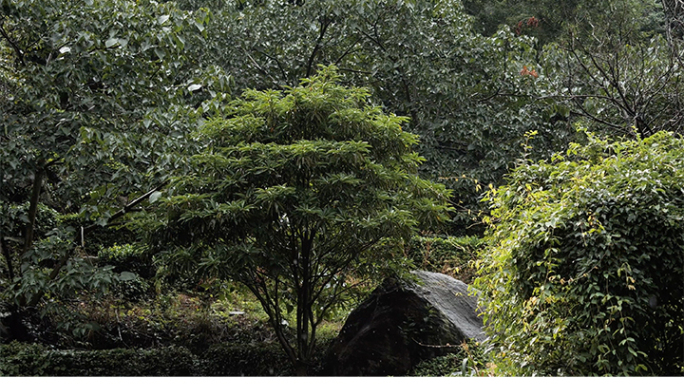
[147,67,449,374]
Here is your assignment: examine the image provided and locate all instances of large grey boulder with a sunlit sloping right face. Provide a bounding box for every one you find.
[324,271,485,376]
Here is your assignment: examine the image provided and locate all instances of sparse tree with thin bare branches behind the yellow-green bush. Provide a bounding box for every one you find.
[532,2,684,137]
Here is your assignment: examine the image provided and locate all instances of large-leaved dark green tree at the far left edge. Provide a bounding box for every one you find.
[0,0,227,330]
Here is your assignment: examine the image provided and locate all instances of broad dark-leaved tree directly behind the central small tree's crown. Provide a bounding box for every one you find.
[200,0,575,232]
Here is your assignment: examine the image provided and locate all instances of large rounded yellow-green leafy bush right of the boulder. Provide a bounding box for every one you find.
[474,133,684,375]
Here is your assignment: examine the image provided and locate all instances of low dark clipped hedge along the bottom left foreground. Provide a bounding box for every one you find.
[0,342,300,376]
